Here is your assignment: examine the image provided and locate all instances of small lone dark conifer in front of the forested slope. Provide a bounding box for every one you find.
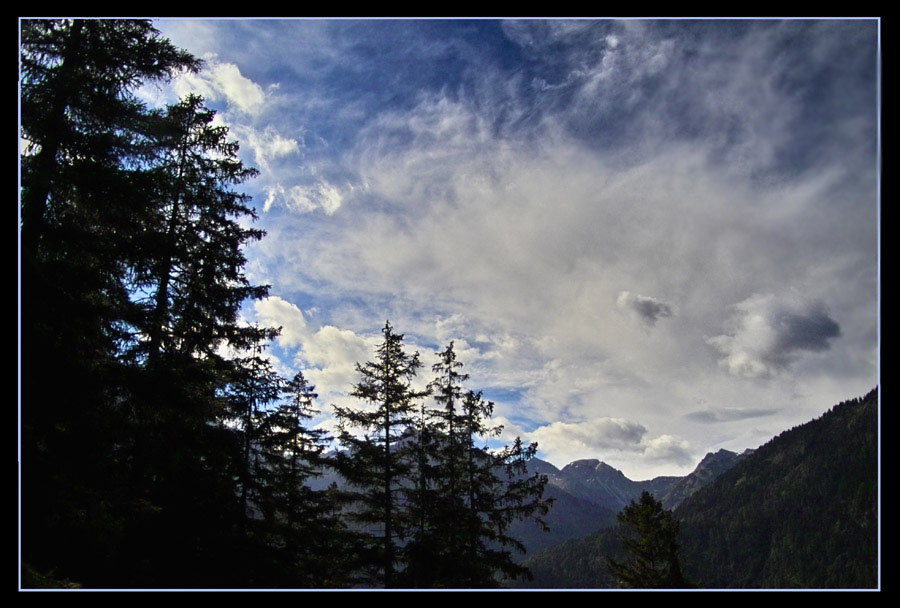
[607,491,690,589]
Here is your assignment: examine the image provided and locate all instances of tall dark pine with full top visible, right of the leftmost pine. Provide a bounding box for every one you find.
[121,95,281,584]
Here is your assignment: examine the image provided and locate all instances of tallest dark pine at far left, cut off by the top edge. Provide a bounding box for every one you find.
[20,19,200,584]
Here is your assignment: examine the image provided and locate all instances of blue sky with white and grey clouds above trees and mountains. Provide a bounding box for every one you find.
[143,19,879,479]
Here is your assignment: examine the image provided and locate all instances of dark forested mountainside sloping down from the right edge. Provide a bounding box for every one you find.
[523,389,879,589]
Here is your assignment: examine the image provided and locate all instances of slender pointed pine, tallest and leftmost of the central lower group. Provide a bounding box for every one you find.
[334,322,427,587]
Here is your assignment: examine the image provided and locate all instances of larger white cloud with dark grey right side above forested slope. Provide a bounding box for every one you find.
[706,294,841,378]
